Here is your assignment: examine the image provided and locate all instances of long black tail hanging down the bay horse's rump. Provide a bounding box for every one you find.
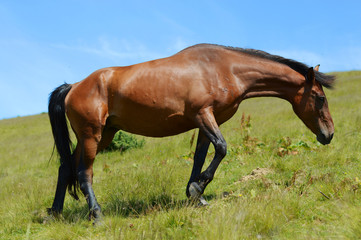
[48,83,79,199]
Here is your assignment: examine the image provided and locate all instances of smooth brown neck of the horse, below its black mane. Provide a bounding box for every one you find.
[236,63,305,101]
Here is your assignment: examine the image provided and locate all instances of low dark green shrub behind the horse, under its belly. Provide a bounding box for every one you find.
[104,131,145,152]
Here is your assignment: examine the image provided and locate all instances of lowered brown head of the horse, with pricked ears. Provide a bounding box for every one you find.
[292,66,334,145]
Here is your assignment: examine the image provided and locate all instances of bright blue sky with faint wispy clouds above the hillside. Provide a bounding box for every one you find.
[0,0,361,119]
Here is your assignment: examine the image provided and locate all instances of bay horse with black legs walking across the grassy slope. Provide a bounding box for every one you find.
[48,44,335,221]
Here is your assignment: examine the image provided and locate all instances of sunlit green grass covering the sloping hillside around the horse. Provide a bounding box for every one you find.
[0,71,361,239]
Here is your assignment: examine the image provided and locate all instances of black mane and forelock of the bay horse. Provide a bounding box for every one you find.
[221,46,335,88]
